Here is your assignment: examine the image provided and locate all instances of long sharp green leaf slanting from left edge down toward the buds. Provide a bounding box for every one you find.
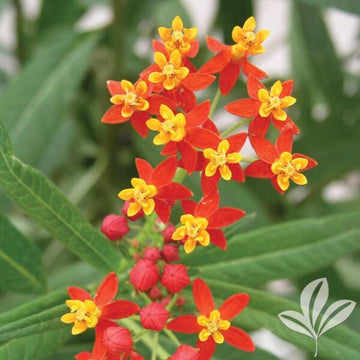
[0,122,119,272]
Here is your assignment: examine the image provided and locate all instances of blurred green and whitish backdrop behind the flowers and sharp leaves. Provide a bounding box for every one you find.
[0,0,360,359]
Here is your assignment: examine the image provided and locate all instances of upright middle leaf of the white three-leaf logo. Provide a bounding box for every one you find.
[300,278,329,328]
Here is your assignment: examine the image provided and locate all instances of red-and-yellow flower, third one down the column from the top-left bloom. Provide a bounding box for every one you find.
[146,100,219,174]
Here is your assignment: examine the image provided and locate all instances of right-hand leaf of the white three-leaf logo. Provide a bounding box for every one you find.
[318,300,356,337]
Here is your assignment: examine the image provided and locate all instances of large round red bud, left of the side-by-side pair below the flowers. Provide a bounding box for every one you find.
[130,259,159,291]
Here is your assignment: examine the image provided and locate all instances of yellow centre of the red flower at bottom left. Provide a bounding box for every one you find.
[60,300,101,335]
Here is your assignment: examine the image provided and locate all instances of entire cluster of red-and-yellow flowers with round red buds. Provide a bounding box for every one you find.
[61,16,317,360]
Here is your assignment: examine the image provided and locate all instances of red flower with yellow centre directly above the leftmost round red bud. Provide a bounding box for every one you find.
[118,157,193,223]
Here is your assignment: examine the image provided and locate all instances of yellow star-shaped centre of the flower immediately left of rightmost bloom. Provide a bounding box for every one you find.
[203,140,242,180]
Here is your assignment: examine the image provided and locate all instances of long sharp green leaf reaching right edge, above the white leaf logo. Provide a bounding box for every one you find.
[185,212,360,286]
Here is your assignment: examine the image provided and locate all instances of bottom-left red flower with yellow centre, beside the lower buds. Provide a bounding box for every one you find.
[61,272,140,335]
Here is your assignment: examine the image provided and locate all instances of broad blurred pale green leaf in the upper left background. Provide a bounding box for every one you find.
[0,29,99,165]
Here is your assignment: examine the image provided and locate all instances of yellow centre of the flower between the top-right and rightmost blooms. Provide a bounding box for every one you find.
[258,80,296,121]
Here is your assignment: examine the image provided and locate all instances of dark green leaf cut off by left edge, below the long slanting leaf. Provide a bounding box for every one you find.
[0,214,45,293]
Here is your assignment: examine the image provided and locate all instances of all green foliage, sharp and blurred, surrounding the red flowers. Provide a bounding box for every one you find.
[0,0,360,360]
